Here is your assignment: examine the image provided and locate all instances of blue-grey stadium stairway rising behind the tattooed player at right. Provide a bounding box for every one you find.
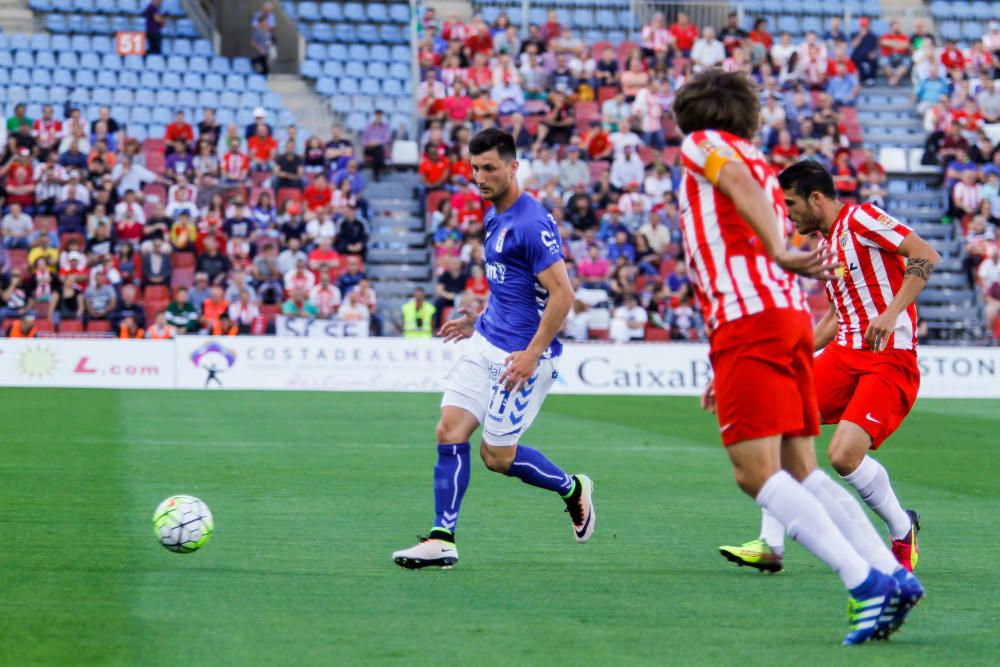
[857,85,984,345]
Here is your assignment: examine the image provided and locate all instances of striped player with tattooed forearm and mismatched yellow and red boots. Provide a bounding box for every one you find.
[721,162,939,571]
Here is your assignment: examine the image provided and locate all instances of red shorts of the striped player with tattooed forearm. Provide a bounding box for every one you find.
[815,343,920,449]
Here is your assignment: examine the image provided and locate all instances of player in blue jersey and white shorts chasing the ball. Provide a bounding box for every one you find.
[392,128,595,569]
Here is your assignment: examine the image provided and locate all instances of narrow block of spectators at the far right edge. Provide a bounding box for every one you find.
[912,21,1000,340]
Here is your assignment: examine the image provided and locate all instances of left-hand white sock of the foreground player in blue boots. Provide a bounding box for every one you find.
[756,470,871,590]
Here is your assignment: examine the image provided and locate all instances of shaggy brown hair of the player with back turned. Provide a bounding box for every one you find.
[674,69,760,139]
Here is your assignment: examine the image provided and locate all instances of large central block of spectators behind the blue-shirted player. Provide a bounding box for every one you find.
[418,10,910,340]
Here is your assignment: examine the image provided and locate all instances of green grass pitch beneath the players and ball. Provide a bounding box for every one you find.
[0,389,1000,667]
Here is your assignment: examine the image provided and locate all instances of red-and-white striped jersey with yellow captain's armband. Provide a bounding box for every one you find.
[680,130,806,329]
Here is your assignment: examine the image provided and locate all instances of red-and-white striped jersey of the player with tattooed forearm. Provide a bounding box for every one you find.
[826,204,917,350]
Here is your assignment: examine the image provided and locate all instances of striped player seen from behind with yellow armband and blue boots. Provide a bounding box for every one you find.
[674,70,923,644]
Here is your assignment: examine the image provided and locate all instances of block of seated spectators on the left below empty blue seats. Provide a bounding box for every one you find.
[0,97,390,338]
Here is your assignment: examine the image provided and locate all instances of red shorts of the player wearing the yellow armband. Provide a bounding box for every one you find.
[709,308,819,446]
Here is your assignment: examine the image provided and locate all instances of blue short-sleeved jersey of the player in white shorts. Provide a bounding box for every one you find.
[476,194,562,357]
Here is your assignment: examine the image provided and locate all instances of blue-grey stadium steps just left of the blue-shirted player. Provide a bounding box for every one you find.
[365,171,434,335]
